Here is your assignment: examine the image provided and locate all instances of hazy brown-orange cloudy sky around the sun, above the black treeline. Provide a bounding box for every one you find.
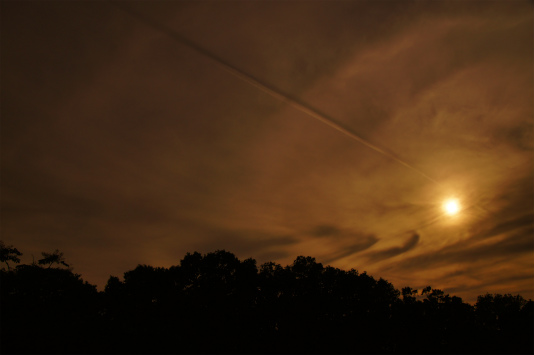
[0,0,534,302]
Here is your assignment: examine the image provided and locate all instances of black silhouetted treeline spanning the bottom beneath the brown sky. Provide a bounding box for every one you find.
[0,243,534,354]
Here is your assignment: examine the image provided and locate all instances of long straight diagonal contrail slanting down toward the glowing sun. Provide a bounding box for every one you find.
[110,2,440,185]
